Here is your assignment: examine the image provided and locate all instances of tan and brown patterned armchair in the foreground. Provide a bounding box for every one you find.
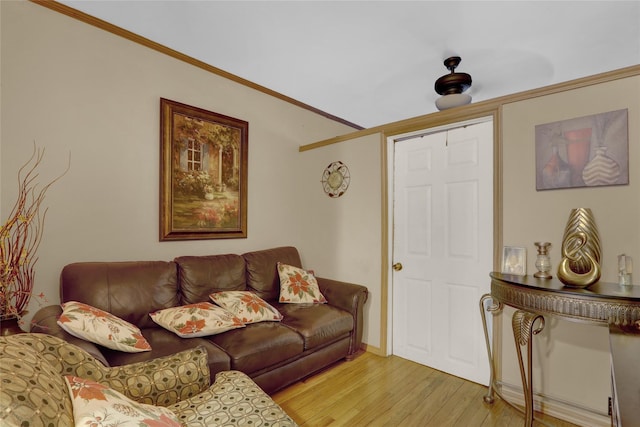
[0,333,296,427]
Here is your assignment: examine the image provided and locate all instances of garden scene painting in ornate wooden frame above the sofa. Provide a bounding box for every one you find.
[160,98,249,241]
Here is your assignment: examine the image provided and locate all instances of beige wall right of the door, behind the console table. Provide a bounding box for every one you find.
[502,76,640,422]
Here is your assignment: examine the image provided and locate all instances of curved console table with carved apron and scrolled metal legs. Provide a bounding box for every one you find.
[480,272,640,426]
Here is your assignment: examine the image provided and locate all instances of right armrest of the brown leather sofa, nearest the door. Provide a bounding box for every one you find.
[316,277,369,355]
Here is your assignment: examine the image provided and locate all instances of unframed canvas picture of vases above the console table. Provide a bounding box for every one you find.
[536,109,629,191]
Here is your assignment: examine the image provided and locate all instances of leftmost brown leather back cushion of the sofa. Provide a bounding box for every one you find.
[60,261,179,328]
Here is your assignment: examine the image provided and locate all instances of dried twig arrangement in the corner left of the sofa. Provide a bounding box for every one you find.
[0,144,71,320]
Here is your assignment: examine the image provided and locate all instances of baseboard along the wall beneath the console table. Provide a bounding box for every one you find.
[498,382,611,427]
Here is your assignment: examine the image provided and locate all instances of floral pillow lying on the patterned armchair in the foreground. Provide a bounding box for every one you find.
[64,375,182,427]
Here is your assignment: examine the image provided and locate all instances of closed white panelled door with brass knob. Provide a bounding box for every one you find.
[392,122,493,384]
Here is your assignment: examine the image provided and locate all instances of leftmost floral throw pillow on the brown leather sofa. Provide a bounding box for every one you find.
[58,301,151,353]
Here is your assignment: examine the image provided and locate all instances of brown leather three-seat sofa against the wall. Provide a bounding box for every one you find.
[31,247,368,393]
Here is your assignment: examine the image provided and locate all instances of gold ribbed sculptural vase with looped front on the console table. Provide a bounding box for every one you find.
[558,208,601,288]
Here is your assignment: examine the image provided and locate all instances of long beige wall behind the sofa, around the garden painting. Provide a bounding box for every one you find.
[0,1,359,321]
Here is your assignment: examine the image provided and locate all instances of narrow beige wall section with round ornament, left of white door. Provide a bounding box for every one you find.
[299,134,382,349]
